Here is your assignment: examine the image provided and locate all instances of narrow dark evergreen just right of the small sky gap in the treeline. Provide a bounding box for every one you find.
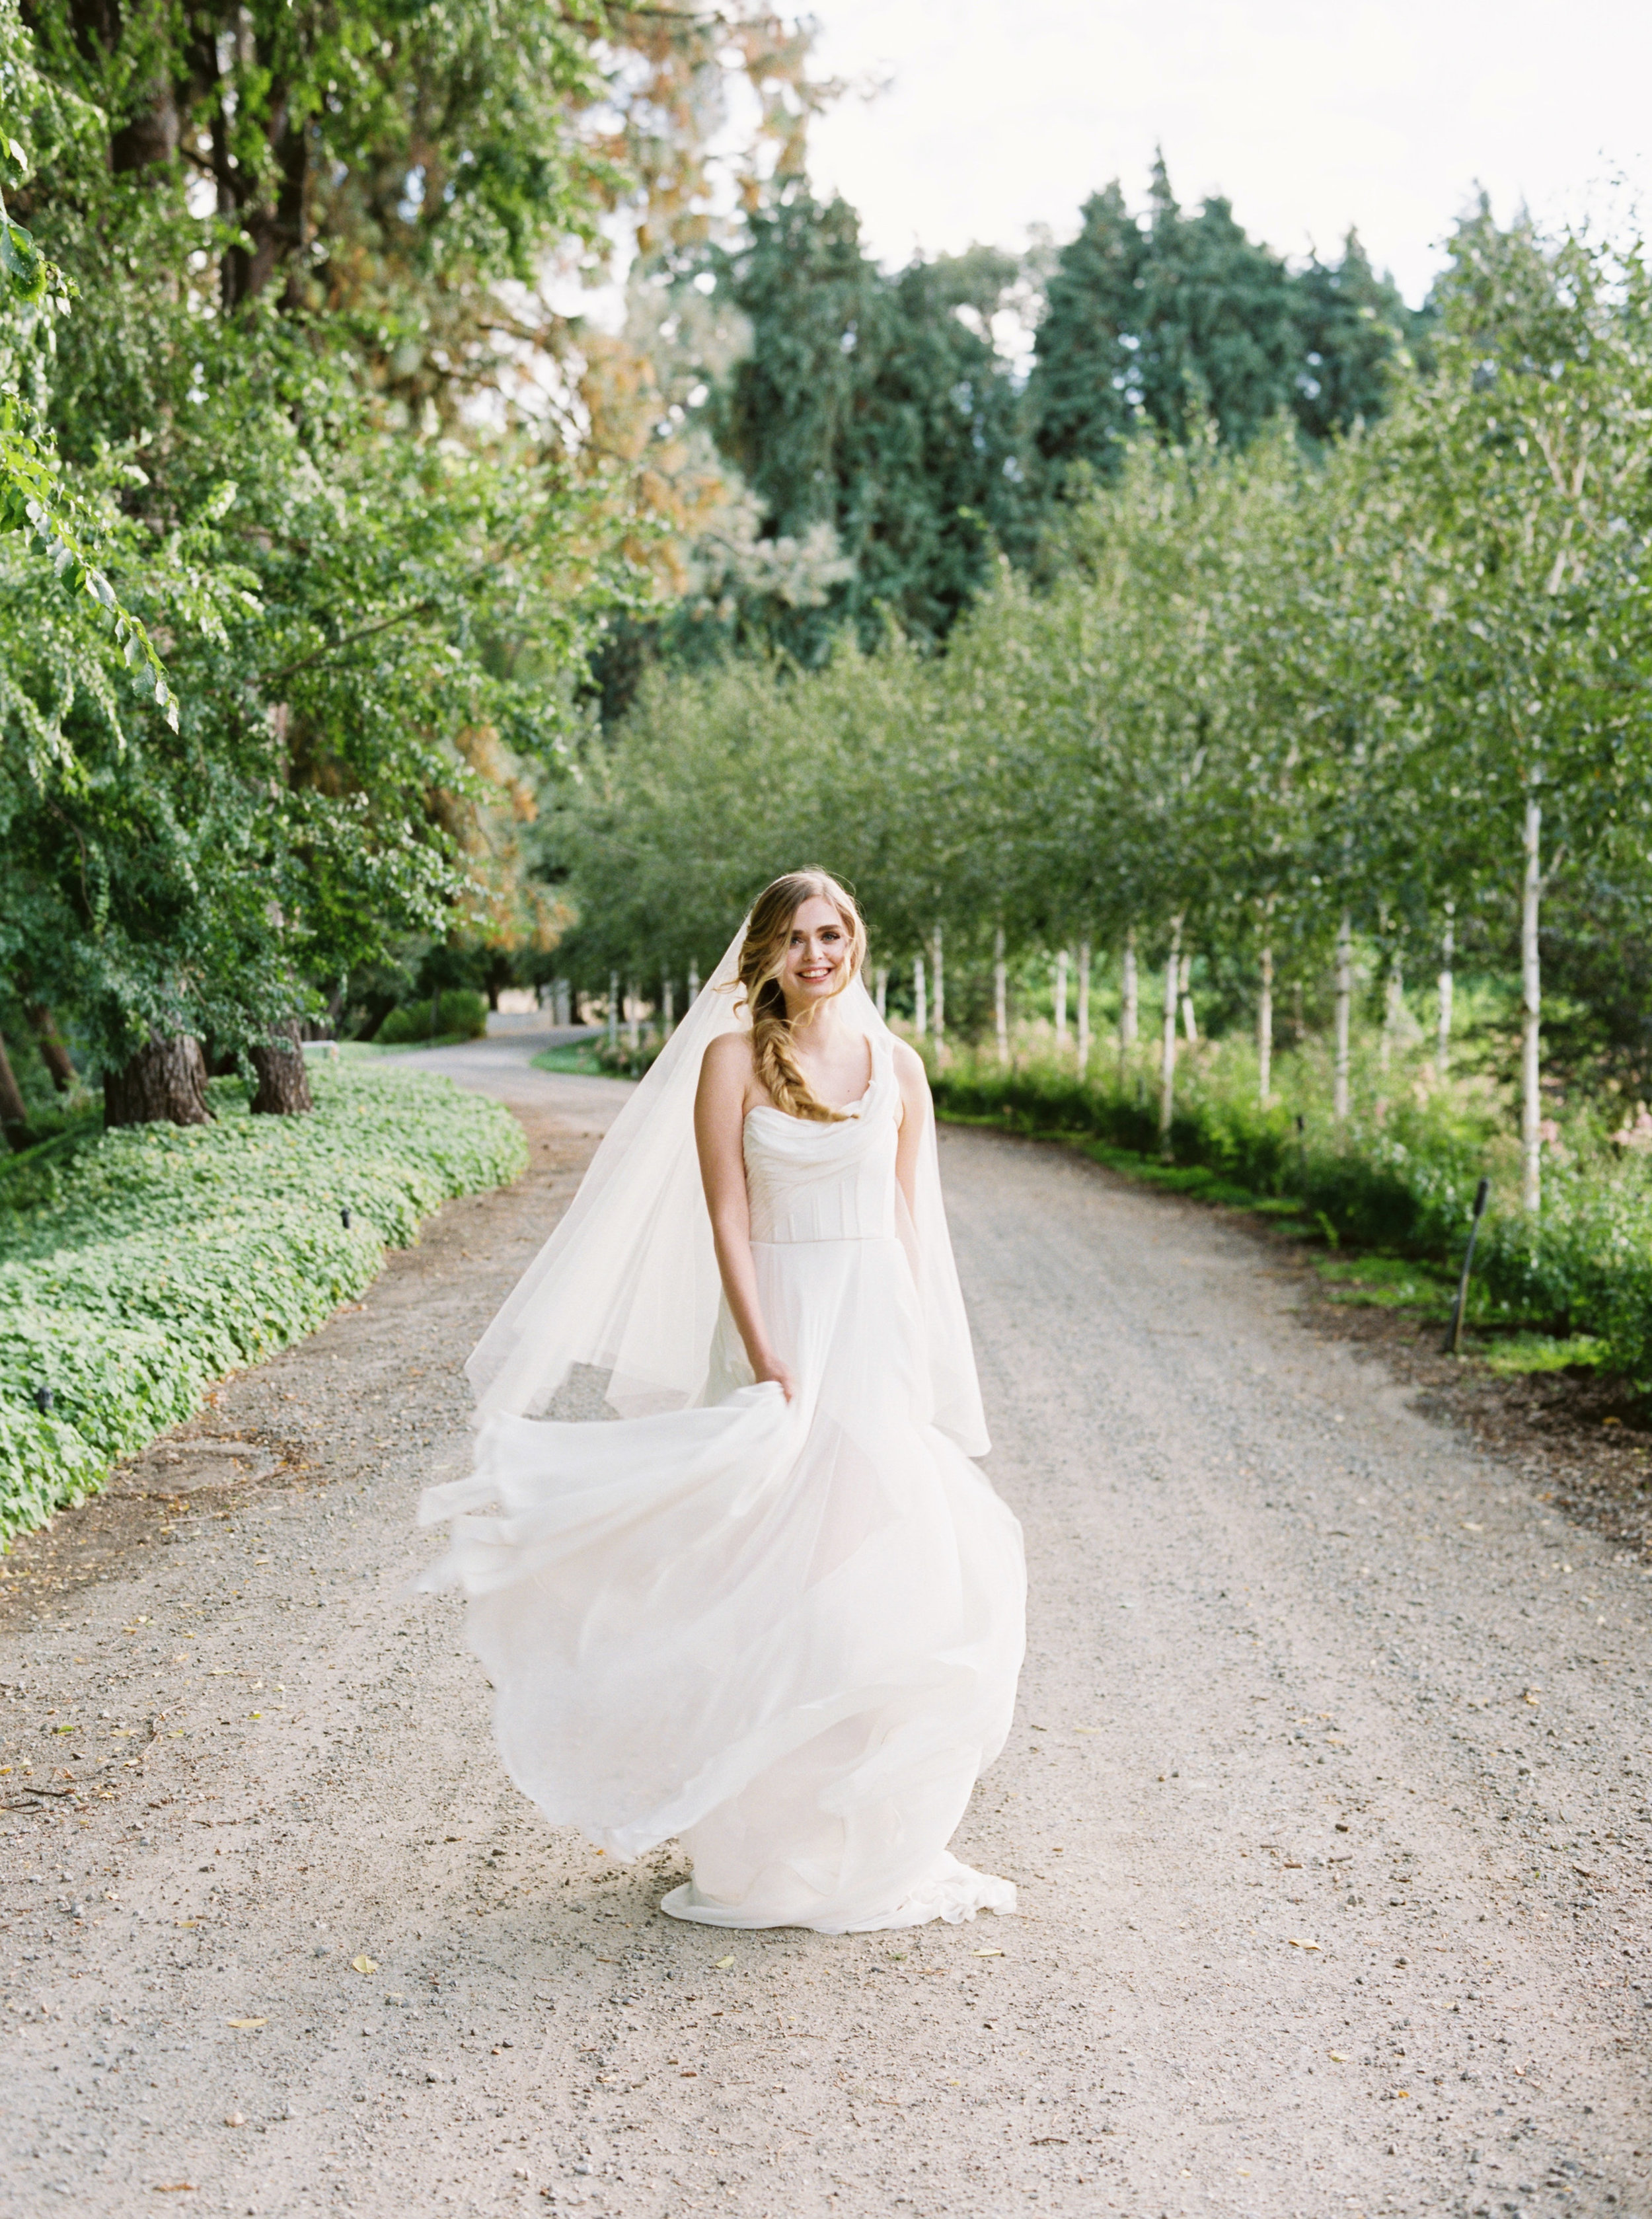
[1026,178,1146,486]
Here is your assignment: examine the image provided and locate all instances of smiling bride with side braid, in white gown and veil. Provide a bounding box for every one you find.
[420,870,1026,1933]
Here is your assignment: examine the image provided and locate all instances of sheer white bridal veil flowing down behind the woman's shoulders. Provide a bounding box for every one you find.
[464,925,988,1456]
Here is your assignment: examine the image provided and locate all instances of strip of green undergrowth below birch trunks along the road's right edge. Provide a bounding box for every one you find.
[932,1043,1652,1391]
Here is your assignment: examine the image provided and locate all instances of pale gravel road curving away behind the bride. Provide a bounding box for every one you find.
[0,1043,1652,2219]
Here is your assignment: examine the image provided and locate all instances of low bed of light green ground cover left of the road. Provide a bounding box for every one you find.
[0,1063,526,1536]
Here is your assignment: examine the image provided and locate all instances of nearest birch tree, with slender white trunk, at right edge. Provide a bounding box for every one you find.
[1392,211,1652,1209]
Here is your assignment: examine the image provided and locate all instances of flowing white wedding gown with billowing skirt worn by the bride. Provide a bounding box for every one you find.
[420,1030,1026,1933]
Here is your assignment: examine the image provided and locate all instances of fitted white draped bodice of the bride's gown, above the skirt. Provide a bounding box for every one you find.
[744,1039,899,1245]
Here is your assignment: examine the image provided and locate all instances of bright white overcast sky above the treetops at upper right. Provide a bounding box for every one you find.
[810,0,1652,302]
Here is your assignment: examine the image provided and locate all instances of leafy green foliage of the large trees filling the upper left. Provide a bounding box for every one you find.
[0,0,815,1100]
